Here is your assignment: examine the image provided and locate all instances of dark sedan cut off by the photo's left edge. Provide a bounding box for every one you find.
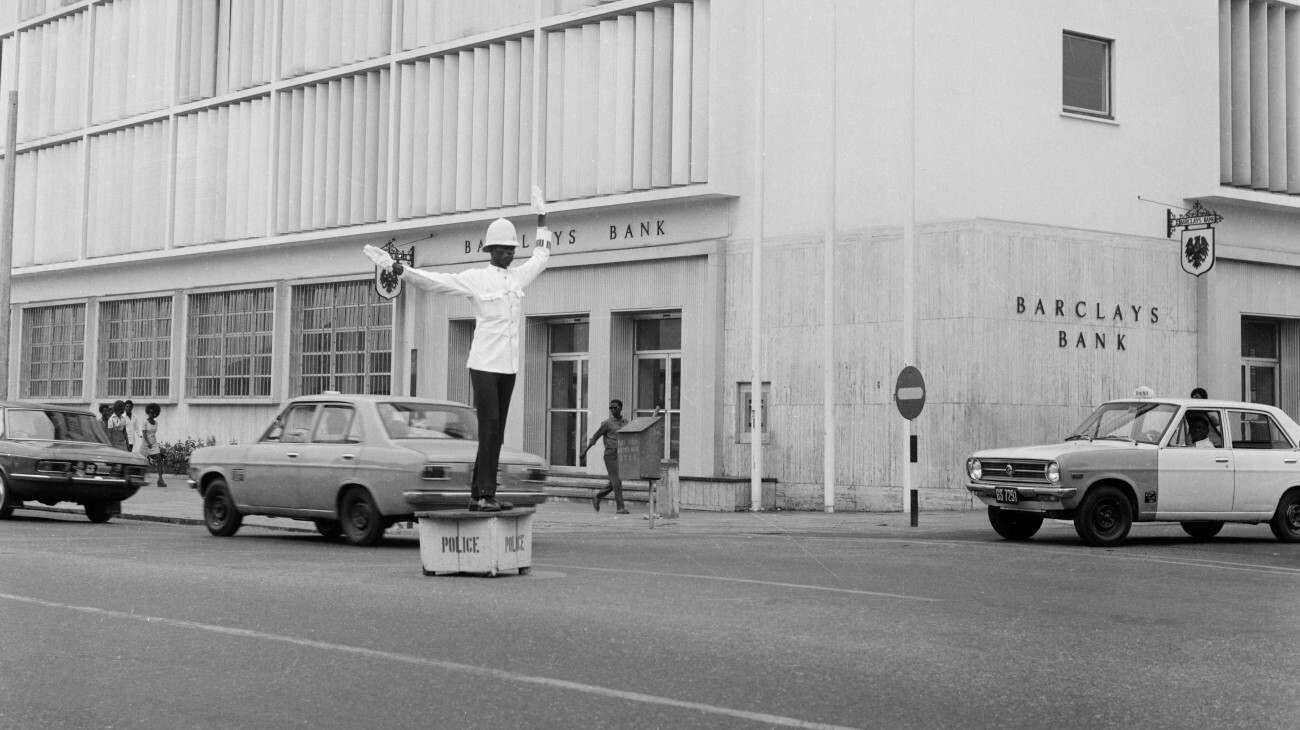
[0,403,148,522]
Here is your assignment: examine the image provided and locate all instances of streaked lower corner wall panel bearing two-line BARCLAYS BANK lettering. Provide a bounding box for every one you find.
[722,221,1197,509]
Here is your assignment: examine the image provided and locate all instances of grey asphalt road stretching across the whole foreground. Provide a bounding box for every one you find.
[0,512,1300,730]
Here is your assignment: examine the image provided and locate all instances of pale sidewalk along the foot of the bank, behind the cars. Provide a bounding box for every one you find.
[23,474,991,536]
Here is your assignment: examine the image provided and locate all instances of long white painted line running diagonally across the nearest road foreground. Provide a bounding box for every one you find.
[0,594,857,730]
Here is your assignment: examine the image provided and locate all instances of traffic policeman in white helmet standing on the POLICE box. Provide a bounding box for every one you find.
[364,218,551,512]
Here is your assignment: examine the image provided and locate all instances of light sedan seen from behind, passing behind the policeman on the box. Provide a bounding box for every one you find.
[190,394,547,546]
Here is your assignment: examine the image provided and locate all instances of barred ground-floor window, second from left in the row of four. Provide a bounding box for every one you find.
[96,296,172,399]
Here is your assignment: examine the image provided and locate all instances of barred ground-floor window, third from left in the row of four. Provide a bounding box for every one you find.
[186,288,274,397]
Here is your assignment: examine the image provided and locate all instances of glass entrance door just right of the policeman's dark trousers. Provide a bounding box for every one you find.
[546,321,589,466]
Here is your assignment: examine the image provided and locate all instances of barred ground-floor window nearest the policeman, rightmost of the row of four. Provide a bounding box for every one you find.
[289,279,393,396]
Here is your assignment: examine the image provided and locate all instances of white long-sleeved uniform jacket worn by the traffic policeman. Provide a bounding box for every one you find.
[402,248,551,373]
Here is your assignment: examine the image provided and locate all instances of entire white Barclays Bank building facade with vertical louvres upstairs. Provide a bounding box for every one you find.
[0,0,1300,510]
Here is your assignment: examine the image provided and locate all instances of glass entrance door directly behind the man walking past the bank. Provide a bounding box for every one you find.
[633,314,681,459]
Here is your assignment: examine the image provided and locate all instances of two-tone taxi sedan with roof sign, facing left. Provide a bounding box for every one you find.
[966,397,1300,547]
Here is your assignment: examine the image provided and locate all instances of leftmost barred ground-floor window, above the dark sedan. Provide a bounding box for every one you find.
[20,304,86,399]
